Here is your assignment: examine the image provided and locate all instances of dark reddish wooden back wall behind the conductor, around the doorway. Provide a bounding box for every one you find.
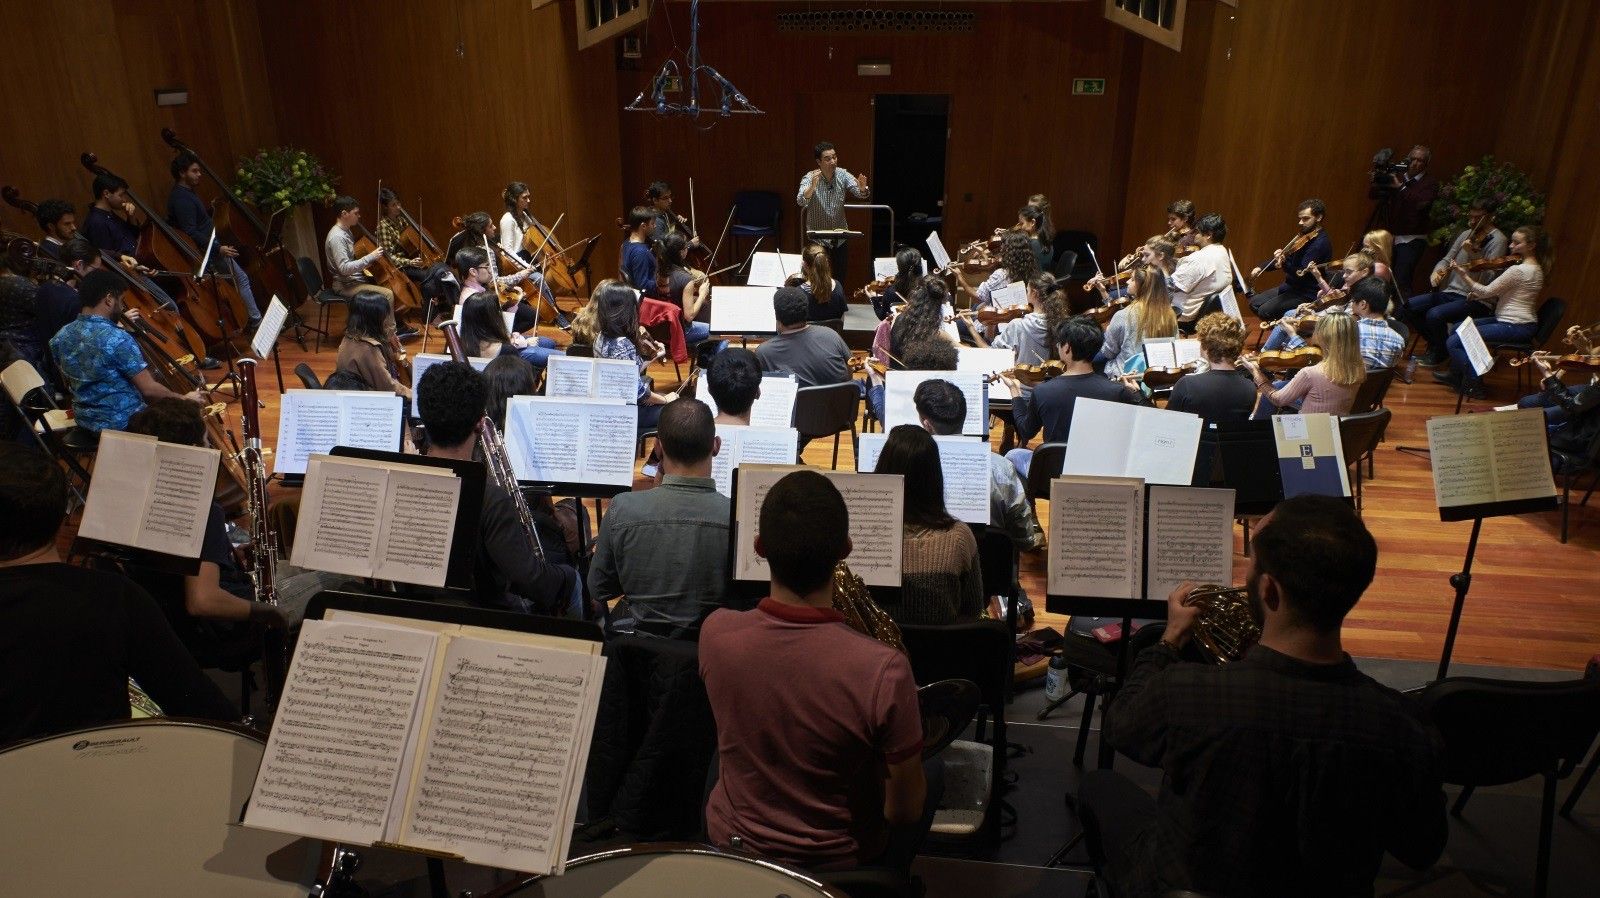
[618,3,1144,288]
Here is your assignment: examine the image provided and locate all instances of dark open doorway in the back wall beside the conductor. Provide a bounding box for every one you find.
[872,93,950,258]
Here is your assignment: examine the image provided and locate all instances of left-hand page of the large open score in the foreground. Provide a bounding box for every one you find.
[245,619,437,845]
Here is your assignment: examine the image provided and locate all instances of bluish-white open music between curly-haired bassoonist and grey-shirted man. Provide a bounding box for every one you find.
[506,395,638,487]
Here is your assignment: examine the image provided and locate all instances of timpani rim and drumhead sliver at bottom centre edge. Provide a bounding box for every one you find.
[485,842,843,898]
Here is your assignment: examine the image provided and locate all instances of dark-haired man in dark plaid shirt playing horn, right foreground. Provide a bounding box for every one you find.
[1078,496,1446,898]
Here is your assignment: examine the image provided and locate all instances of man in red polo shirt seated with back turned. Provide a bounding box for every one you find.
[699,471,931,868]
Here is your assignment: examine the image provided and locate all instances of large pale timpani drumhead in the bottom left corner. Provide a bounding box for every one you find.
[0,717,322,898]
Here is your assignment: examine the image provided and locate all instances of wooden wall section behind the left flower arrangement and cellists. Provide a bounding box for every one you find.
[259,0,621,277]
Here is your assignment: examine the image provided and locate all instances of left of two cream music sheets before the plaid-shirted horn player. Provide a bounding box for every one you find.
[1046,477,1144,599]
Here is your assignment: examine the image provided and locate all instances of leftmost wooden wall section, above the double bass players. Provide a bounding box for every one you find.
[0,0,277,235]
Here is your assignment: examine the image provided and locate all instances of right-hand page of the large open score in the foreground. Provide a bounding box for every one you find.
[400,637,605,871]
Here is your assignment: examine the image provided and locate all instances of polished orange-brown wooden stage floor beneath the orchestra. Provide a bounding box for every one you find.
[229,300,1600,671]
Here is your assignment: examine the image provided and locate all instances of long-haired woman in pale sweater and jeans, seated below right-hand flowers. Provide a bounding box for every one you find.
[1434,224,1555,399]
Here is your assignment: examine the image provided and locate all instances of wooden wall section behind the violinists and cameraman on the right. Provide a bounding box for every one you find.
[1122,0,1539,280]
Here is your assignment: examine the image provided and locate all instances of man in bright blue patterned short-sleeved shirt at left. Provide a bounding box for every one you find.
[50,269,205,435]
